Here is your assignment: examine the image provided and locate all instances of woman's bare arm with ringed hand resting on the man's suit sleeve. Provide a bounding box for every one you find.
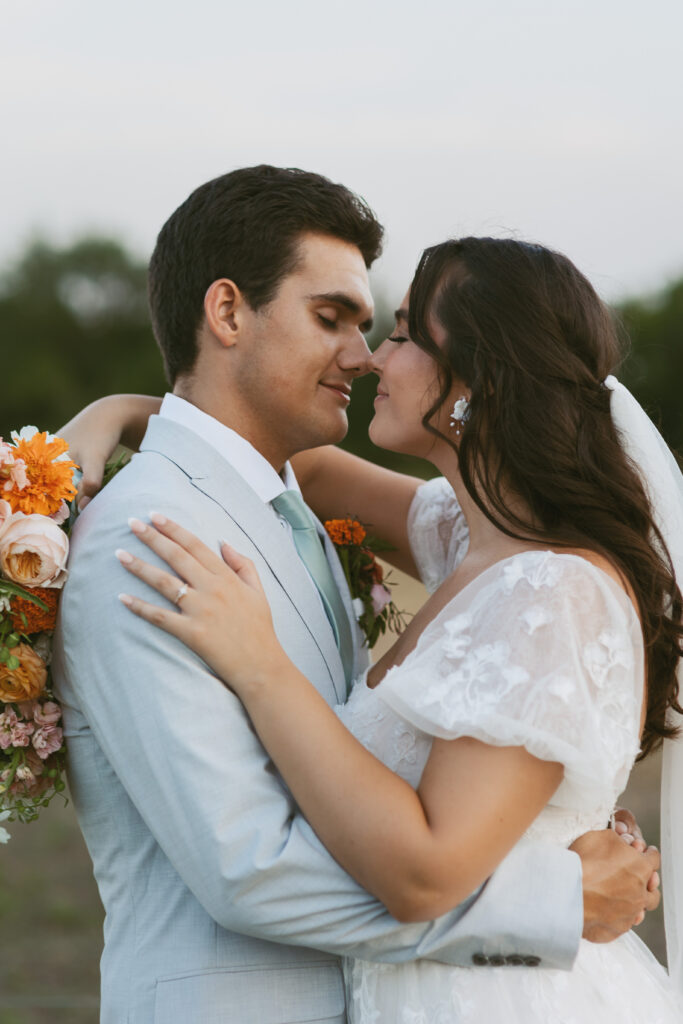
[119,517,563,922]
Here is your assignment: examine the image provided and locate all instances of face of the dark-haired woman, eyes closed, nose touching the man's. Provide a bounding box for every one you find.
[369,292,469,459]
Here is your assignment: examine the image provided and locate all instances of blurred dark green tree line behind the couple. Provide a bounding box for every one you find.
[0,238,683,466]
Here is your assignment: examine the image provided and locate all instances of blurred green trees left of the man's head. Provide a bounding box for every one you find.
[0,238,164,437]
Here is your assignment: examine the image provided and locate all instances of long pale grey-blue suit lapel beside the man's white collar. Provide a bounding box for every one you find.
[140,417,355,703]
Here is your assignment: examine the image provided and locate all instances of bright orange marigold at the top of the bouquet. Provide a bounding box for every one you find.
[2,432,78,515]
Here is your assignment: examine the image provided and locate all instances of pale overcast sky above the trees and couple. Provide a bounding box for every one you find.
[0,0,683,301]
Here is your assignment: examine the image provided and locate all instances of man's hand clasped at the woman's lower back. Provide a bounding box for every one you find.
[569,829,660,942]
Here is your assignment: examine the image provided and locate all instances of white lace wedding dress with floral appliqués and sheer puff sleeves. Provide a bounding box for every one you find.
[337,479,683,1024]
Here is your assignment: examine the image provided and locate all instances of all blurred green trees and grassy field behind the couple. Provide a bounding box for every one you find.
[0,237,683,1024]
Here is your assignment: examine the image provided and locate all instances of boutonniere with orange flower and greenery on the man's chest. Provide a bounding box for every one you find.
[325,516,405,648]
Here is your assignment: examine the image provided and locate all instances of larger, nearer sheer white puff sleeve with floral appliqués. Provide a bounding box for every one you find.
[377,551,644,809]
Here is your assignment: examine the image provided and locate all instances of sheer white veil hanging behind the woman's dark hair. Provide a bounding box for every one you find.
[605,377,683,992]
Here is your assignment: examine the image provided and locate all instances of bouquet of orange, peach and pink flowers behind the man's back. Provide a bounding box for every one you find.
[0,427,78,843]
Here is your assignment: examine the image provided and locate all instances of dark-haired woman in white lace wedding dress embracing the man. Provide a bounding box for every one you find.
[63,239,683,1024]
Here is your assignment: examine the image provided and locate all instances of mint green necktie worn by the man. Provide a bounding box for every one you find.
[270,490,353,684]
